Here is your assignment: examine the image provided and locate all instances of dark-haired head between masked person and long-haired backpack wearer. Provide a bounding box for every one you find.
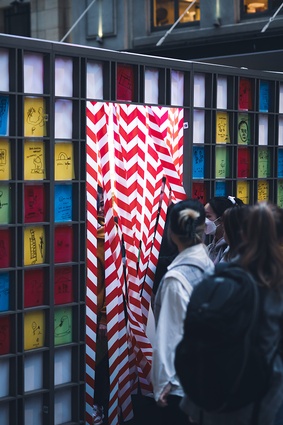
[222,205,249,261]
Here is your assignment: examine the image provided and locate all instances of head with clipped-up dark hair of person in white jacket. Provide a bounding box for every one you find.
[169,199,205,251]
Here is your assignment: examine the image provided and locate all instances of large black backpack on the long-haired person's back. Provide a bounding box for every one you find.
[175,263,271,412]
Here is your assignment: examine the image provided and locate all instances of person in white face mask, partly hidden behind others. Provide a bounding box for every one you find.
[205,196,244,264]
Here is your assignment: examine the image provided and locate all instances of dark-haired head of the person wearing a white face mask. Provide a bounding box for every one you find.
[204,196,244,239]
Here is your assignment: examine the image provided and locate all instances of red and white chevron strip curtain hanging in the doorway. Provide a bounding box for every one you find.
[86,102,186,425]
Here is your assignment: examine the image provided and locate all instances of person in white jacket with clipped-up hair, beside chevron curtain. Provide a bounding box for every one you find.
[151,199,214,425]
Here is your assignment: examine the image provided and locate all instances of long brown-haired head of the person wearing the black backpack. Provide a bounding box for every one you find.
[239,202,283,288]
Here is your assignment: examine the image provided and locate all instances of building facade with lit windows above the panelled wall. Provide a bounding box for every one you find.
[0,0,283,71]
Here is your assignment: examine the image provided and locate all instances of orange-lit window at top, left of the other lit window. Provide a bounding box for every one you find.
[153,0,200,28]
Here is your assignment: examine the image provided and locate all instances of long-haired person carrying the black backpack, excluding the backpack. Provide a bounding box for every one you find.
[181,202,283,425]
